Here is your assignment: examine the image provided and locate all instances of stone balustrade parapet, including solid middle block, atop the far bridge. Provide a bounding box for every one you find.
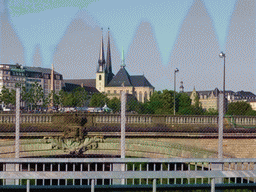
[0,113,256,126]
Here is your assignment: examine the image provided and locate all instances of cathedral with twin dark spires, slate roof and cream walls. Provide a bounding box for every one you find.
[64,32,154,103]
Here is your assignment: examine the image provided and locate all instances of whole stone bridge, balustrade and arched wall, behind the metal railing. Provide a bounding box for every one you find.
[0,114,256,158]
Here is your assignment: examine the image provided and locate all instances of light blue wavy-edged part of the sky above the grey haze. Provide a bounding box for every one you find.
[5,0,255,90]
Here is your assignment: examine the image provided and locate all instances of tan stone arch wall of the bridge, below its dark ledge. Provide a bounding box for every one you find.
[0,133,256,158]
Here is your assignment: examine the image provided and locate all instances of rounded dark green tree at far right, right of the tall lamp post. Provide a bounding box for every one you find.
[226,101,253,115]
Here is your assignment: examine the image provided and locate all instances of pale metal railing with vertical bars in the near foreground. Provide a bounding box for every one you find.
[0,158,256,190]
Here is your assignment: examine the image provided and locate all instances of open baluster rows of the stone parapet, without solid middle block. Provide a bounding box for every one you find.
[0,114,256,126]
